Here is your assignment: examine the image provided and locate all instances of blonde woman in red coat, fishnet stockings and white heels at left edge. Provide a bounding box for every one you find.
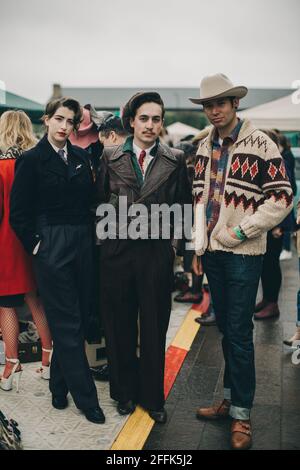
[0,111,52,391]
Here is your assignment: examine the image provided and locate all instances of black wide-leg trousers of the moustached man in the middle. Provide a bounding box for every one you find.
[101,240,174,410]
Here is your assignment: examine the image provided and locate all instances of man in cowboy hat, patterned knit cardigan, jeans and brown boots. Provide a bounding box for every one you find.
[191,74,293,449]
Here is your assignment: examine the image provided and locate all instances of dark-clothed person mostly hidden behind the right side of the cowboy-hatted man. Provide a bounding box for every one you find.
[254,130,294,320]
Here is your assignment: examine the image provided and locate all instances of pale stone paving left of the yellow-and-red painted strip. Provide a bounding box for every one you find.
[0,292,189,450]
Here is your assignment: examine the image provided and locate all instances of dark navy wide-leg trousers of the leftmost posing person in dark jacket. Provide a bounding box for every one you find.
[34,225,98,410]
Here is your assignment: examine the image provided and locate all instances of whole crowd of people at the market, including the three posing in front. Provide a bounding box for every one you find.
[0,74,300,449]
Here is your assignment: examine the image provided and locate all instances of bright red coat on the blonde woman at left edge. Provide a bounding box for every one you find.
[0,152,36,296]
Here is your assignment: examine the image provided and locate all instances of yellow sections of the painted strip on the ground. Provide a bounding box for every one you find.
[110,309,202,450]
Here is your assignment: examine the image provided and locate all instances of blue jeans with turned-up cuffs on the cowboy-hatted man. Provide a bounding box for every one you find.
[202,251,263,419]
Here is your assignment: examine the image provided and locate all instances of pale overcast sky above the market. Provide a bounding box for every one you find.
[0,0,300,102]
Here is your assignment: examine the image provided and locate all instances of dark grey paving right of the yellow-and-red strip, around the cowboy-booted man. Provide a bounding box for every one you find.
[144,252,300,450]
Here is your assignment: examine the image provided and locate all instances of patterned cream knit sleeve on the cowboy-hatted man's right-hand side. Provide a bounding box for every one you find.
[240,139,293,238]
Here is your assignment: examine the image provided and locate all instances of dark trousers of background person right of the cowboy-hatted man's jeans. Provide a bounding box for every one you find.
[261,231,283,303]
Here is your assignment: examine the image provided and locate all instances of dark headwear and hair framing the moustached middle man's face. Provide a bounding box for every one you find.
[122,91,165,134]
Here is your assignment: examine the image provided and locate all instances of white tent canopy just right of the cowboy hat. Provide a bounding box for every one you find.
[239,95,300,131]
